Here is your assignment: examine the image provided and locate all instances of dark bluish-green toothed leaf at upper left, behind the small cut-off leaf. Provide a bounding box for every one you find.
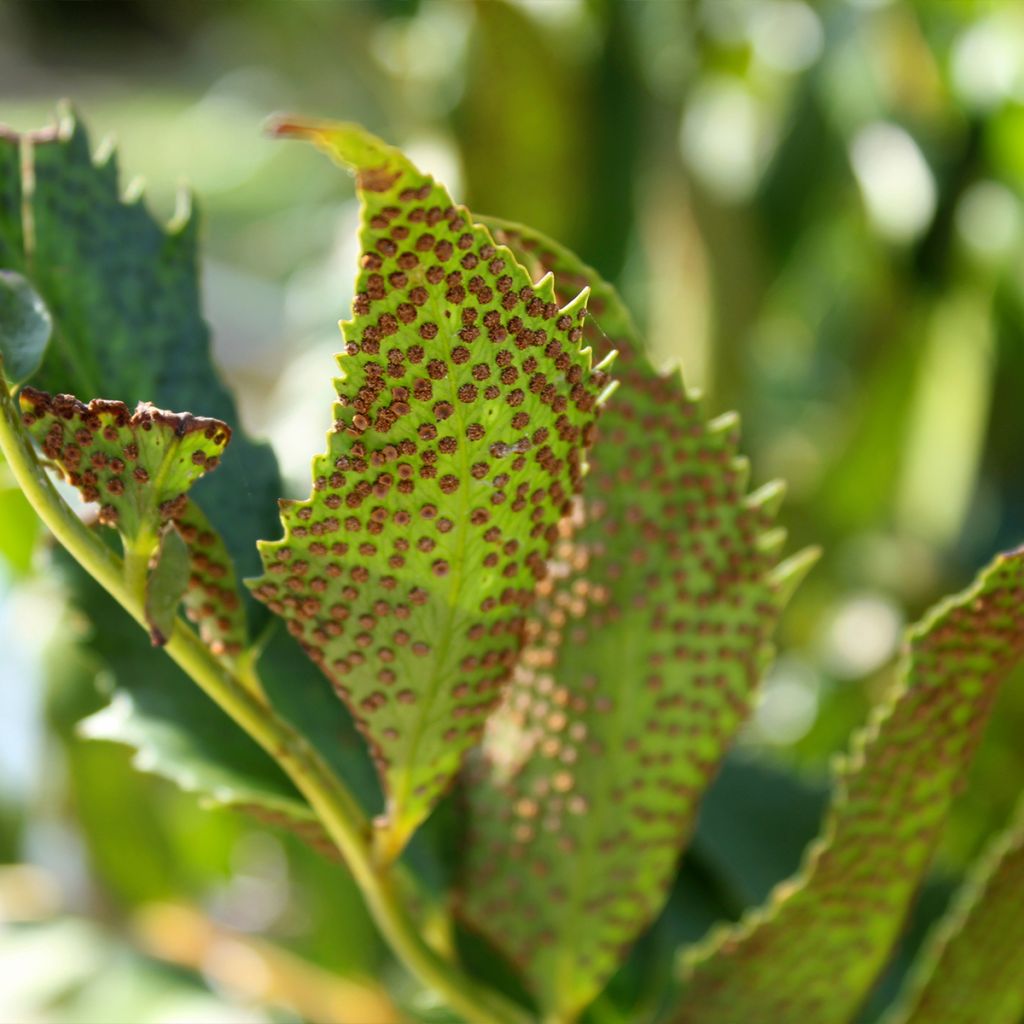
[0,112,281,593]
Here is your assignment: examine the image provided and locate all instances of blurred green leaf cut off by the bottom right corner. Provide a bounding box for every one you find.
[886,799,1024,1024]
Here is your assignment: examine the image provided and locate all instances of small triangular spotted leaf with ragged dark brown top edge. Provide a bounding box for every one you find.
[20,387,231,540]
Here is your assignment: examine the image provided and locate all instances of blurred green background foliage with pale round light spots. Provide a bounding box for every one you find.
[0,0,1024,1024]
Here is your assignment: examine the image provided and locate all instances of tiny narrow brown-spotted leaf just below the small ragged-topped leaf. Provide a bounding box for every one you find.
[176,500,248,657]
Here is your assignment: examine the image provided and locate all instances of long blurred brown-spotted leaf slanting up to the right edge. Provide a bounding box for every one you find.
[672,549,1024,1024]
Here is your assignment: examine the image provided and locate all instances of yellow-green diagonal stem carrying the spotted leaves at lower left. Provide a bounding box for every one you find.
[0,376,529,1024]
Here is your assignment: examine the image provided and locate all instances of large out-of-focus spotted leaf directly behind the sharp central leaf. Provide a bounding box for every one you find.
[460,223,808,1020]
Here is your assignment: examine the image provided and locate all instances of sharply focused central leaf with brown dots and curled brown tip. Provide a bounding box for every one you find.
[248,121,606,857]
